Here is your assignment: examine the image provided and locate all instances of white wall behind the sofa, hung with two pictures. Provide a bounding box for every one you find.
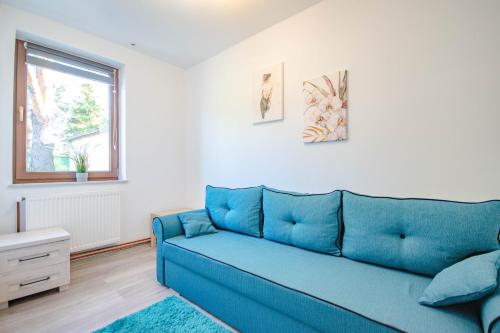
[186,0,500,206]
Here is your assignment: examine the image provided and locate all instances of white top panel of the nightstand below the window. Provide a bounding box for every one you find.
[0,228,70,252]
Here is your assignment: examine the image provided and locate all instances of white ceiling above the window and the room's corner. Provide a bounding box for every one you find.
[0,0,320,68]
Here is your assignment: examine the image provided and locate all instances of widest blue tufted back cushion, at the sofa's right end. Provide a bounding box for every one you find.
[342,191,500,275]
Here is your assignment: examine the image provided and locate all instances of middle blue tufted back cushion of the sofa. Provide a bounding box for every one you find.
[263,189,341,256]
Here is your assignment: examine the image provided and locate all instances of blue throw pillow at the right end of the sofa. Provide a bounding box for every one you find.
[419,251,500,306]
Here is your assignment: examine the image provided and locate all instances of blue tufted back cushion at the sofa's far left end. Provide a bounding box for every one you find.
[205,185,262,237]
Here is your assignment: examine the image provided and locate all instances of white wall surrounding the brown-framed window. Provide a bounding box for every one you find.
[0,5,185,242]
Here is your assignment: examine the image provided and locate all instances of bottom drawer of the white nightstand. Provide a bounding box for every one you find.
[0,261,69,302]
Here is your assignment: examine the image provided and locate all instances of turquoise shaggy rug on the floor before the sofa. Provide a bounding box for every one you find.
[95,296,230,333]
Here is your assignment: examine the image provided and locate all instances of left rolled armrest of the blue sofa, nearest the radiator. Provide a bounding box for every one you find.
[153,209,205,285]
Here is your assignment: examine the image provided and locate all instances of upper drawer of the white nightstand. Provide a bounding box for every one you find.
[0,240,69,277]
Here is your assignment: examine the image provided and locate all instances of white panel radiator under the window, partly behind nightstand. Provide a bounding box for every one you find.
[20,191,120,252]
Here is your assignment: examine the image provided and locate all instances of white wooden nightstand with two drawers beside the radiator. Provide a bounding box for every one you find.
[0,228,70,309]
